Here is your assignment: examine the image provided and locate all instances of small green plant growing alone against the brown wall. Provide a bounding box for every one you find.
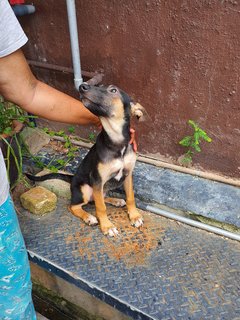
[179,120,212,165]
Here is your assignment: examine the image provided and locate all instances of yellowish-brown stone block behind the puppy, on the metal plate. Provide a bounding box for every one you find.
[20,186,57,215]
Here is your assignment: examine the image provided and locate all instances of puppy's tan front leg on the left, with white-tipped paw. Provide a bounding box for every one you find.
[93,185,118,237]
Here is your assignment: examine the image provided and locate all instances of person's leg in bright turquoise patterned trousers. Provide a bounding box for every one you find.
[0,196,36,320]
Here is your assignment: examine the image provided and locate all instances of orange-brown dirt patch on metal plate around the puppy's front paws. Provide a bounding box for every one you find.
[65,206,164,267]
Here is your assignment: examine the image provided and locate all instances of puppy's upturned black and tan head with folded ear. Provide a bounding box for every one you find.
[79,83,145,121]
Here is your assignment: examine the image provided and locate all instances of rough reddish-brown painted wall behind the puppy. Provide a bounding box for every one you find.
[21,0,240,177]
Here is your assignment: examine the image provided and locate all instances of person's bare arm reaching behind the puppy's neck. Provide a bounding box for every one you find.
[0,50,100,125]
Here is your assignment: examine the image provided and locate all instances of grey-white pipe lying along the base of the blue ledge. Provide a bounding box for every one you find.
[138,204,240,241]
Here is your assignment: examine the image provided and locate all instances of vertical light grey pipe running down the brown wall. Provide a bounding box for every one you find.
[66,0,83,90]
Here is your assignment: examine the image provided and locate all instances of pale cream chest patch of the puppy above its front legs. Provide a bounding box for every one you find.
[98,152,136,184]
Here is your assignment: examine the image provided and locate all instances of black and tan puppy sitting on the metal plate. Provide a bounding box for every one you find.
[27,83,144,236]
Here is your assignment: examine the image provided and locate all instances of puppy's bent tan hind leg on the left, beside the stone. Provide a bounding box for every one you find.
[69,184,98,225]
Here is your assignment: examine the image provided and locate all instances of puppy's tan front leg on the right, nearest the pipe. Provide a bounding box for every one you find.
[124,172,143,228]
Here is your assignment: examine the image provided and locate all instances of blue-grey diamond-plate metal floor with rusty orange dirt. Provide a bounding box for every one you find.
[17,200,240,320]
